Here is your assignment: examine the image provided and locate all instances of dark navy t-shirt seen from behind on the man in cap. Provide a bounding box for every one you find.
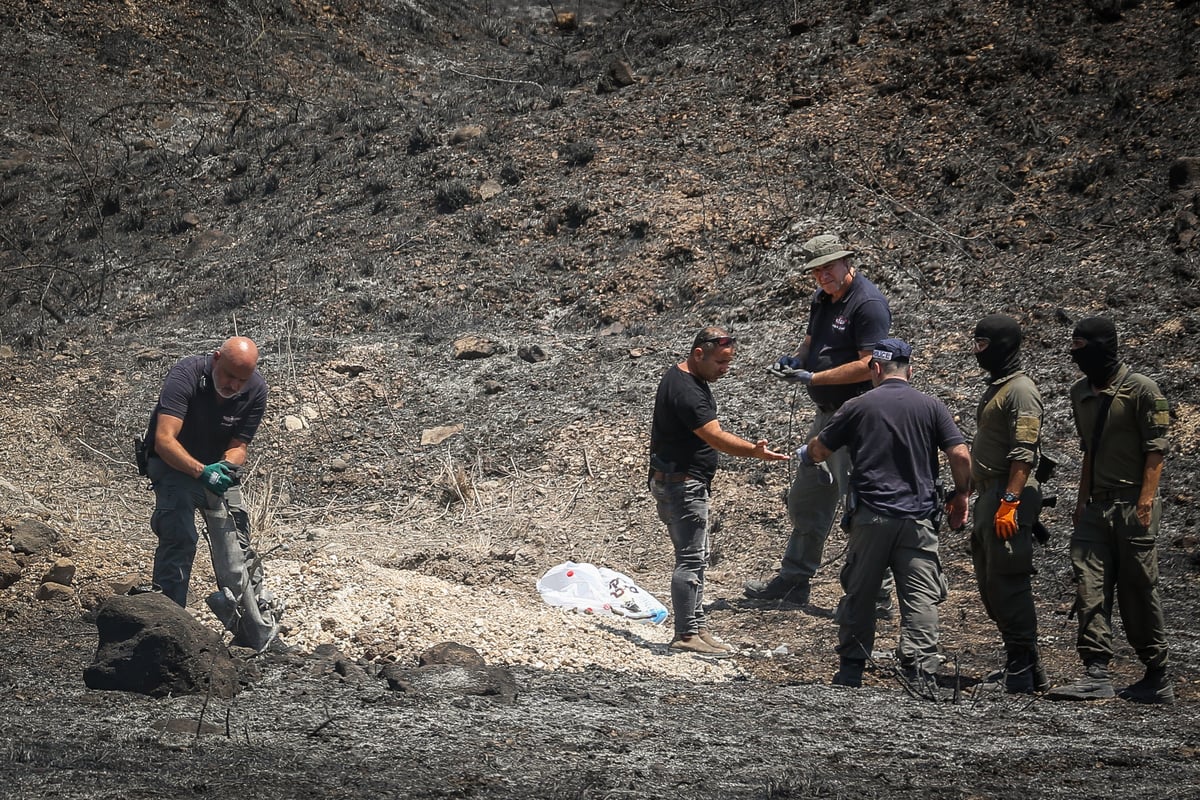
[817,379,966,519]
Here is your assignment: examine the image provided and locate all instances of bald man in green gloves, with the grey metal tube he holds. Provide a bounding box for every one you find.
[145,337,286,650]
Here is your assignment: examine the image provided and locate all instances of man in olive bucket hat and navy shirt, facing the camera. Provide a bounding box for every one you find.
[745,234,892,618]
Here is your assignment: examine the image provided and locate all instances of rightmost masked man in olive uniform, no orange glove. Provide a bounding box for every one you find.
[1048,317,1175,704]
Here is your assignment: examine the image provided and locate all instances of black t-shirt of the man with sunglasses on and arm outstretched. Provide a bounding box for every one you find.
[650,365,716,483]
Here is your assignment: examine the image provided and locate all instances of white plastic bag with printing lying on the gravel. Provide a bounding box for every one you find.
[538,561,667,625]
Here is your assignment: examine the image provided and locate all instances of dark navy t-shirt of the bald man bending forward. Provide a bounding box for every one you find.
[146,355,266,464]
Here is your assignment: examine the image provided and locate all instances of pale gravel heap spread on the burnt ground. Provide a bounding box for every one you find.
[266,553,743,681]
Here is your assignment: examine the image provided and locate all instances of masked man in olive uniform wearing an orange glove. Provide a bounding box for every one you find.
[971,314,1050,693]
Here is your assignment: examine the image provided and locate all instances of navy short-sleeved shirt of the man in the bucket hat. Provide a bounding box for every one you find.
[804,272,892,410]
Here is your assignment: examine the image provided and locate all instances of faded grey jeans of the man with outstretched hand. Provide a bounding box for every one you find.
[650,479,709,636]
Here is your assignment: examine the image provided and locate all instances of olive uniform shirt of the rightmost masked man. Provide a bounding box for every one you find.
[1070,365,1171,493]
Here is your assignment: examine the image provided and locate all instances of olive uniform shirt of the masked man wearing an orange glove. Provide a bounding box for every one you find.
[971,371,1042,487]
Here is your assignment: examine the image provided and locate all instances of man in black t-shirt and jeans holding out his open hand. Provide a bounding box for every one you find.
[648,327,787,657]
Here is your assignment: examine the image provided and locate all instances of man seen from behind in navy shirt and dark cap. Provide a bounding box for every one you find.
[796,338,971,691]
